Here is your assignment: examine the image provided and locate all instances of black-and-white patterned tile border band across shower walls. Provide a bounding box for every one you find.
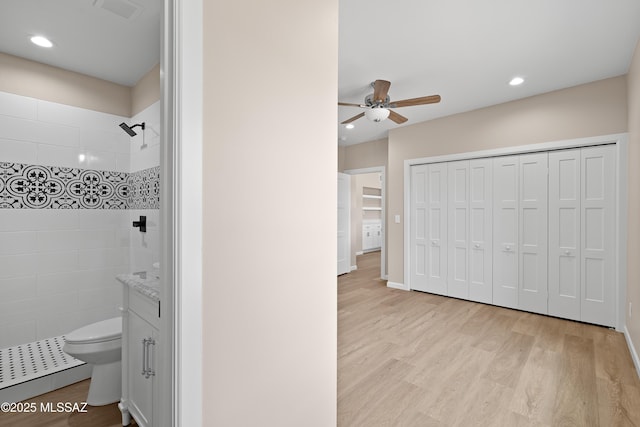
[0,162,160,209]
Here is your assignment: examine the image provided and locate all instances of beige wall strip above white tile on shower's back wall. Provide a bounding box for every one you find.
[0,53,131,117]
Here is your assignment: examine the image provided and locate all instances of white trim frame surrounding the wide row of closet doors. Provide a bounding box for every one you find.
[397,133,629,332]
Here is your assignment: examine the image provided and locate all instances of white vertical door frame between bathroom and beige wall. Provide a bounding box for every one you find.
[160,0,203,427]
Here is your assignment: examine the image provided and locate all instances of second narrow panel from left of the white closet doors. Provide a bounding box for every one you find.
[427,163,447,295]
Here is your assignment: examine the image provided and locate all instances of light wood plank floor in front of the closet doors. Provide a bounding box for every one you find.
[338,253,640,427]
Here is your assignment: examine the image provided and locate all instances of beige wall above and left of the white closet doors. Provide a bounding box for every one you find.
[387,76,632,283]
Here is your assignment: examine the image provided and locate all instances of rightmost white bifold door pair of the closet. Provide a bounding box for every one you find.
[549,146,616,326]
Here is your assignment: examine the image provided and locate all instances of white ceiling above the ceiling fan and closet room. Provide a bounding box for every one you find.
[338,0,640,145]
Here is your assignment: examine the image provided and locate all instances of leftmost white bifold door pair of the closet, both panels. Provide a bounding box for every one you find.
[410,163,447,295]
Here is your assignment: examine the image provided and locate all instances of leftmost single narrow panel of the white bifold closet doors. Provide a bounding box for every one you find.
[409,165,429,292]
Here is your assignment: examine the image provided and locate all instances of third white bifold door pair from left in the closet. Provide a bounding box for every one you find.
[493,153,547,314]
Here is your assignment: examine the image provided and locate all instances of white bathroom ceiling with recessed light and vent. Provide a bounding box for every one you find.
[0,0,162,86]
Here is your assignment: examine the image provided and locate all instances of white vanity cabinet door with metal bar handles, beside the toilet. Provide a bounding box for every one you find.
[128,311,157,426]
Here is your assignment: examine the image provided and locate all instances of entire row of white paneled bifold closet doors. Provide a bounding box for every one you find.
[408,145,617,326]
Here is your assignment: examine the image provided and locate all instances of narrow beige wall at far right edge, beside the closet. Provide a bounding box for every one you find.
[626,43,640,368]
